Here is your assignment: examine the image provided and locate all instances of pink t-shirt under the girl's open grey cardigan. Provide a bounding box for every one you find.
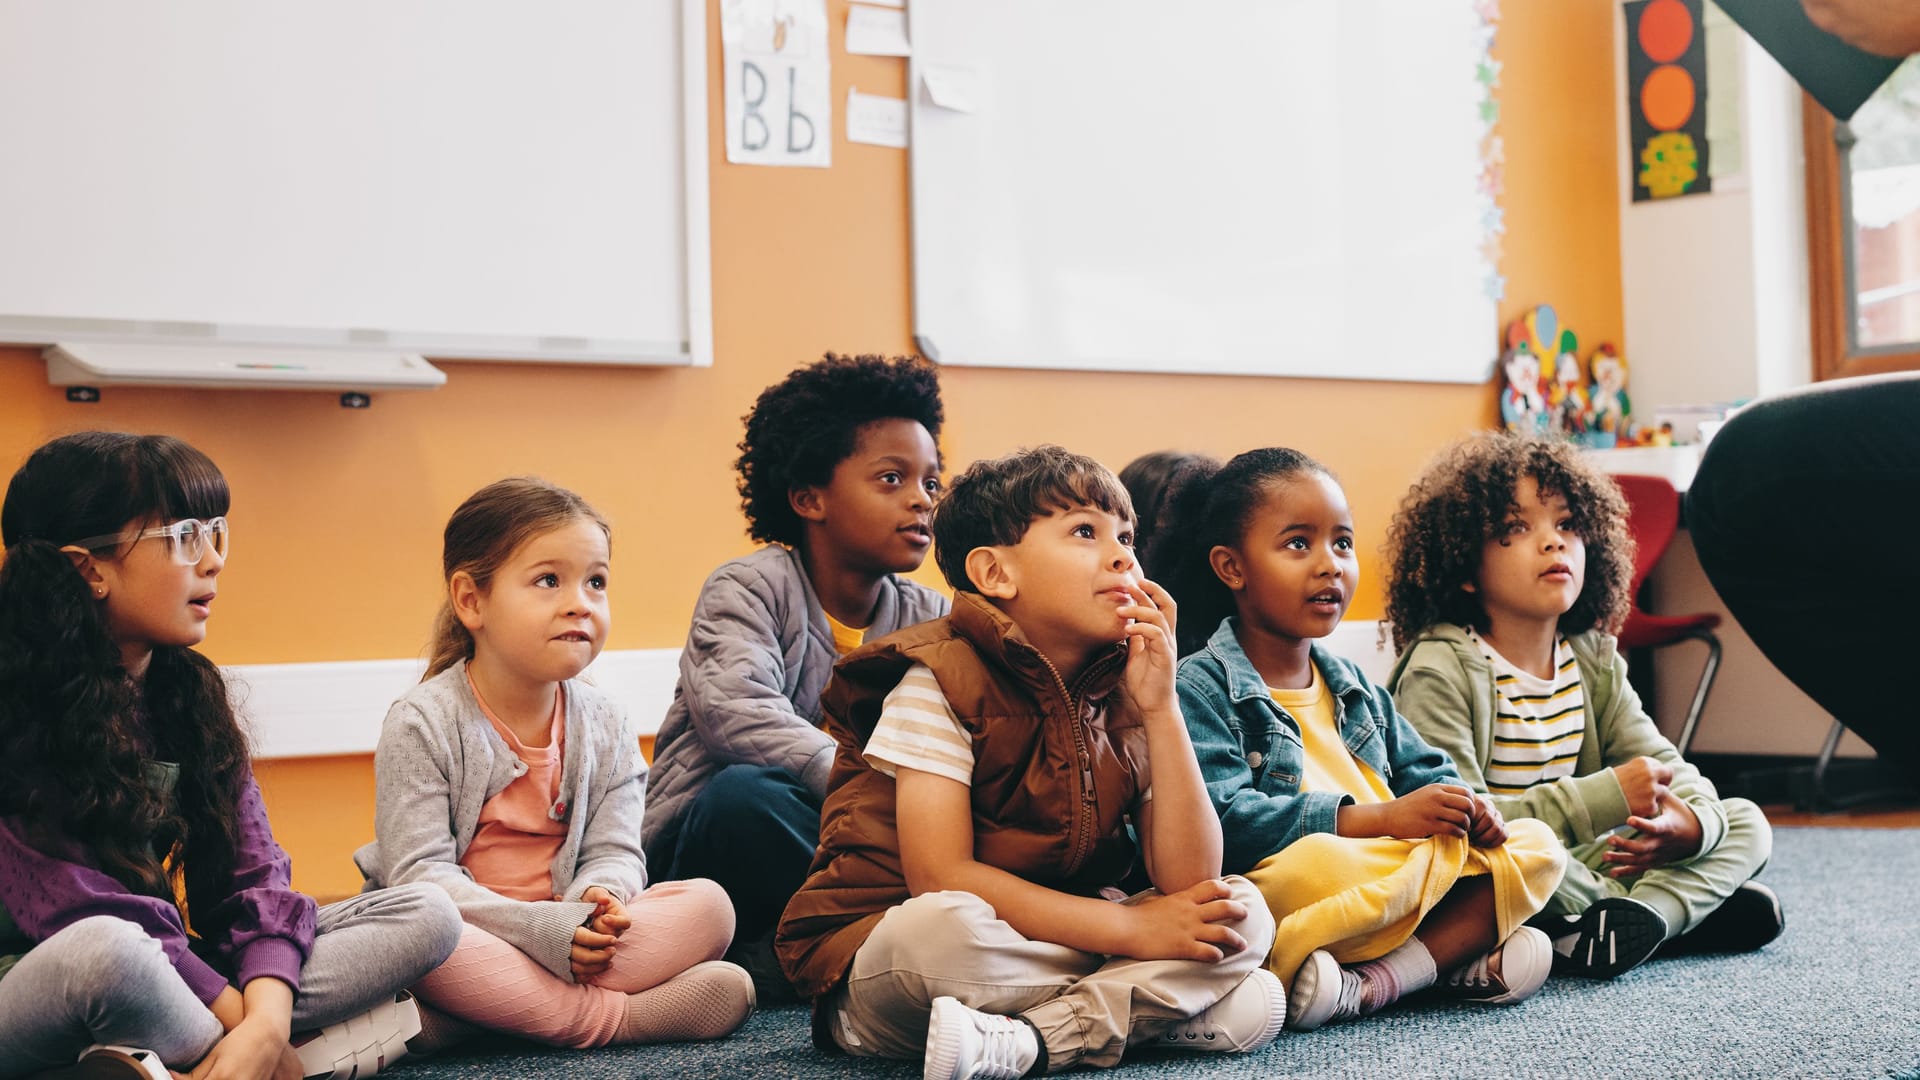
[461,676,566,899]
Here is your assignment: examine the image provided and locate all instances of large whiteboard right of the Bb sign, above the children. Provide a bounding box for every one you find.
[910,0,1497,382]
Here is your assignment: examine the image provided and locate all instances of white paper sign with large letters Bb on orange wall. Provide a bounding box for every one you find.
[720,0,833,169]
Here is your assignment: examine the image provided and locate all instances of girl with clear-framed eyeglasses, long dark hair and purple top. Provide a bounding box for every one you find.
[0,432,459,1080]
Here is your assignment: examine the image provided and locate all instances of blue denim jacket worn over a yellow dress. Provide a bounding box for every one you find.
[1177,617,1461,874]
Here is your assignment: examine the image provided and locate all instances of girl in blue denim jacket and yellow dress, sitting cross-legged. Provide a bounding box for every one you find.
[1148,448,1565,1030]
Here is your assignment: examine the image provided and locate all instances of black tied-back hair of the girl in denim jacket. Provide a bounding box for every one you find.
[1146,446,1332,655]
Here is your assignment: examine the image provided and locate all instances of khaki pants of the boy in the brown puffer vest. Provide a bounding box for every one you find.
[826,878,1273,1070]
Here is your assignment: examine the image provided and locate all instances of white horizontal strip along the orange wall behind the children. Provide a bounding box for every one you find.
[227,621,1394,757]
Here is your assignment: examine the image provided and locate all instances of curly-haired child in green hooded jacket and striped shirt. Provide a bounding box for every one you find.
[1386,434,1782,978]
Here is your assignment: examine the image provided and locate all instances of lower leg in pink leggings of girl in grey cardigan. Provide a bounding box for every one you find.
[413,914,626,1049]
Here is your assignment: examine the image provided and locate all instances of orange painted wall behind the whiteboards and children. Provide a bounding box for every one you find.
[0,0,1620,896]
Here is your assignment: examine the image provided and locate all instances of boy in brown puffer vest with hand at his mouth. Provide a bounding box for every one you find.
[776,448,1284,1078]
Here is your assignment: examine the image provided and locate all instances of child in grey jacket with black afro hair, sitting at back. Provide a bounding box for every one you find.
[641,354,947,1001]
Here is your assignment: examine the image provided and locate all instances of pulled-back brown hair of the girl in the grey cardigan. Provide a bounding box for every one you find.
[420,477,612,682]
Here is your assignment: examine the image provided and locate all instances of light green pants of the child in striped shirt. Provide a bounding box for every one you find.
[1546,799,1774,938]
